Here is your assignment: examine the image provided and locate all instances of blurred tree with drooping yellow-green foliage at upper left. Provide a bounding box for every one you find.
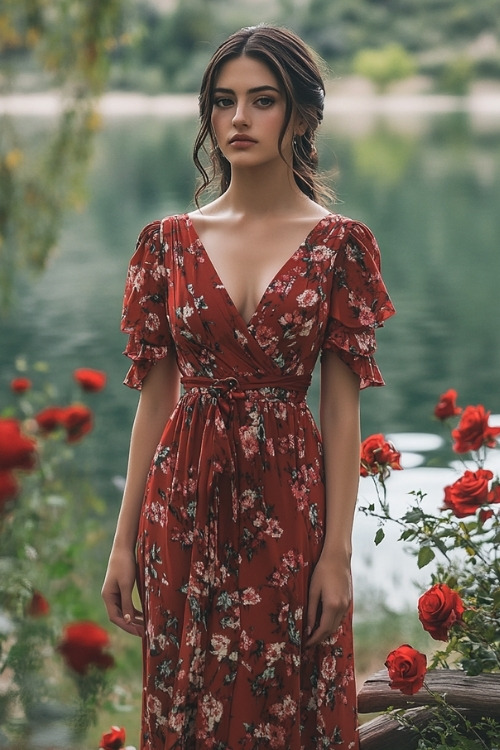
[0,0,126,305]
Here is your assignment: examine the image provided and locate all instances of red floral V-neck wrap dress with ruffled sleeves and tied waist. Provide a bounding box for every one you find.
[122,215,394,750]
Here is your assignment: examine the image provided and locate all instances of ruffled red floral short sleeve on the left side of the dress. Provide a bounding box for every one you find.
[121,221,173,390]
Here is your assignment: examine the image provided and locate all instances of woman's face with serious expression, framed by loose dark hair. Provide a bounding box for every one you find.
[211,55,294,168]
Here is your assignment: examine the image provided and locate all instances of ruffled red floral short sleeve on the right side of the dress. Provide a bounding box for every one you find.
[322,221,395,388]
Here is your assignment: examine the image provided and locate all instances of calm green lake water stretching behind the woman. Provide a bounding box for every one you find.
[0,95,500,604]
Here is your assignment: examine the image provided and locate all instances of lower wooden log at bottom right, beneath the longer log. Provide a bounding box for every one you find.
[359,706,431,750]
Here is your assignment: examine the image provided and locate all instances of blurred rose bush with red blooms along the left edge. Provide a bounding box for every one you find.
[0,362,121,750]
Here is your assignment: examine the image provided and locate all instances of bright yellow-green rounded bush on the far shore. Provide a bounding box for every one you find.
[353,44,417,91]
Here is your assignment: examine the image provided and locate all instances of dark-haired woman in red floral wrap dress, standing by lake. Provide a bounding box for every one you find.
[103,26,394,750]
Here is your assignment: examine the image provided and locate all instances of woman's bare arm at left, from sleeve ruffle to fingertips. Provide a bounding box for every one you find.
[102,352,179,635]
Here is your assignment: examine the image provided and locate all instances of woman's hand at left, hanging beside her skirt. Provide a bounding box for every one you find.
[101,550,144,637]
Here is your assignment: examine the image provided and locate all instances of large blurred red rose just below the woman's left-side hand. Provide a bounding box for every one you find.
[58,622,114,674]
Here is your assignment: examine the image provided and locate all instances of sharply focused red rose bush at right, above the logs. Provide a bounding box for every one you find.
[360,389,500,750]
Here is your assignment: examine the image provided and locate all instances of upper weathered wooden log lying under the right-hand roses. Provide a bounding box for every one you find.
[358,669,500,719]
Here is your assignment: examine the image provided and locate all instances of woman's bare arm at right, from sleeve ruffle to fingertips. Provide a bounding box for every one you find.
[306,352,361,646]
